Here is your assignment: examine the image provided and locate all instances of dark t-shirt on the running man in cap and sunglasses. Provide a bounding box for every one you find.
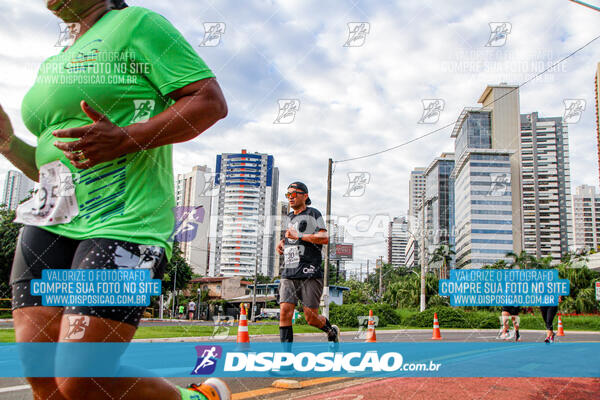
[281,207,326,279]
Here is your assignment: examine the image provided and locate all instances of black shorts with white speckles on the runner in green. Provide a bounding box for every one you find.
[10,225,167,326]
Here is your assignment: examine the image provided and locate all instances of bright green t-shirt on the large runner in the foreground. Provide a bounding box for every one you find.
[21,7,214,259]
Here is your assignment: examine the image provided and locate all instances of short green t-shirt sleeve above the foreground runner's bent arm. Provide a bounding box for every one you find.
[130,9,215,96]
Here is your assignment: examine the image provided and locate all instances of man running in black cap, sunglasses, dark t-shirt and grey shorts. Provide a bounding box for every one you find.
[277,182,339,351]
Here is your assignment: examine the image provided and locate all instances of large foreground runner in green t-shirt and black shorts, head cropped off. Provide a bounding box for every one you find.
[0,0,229,400]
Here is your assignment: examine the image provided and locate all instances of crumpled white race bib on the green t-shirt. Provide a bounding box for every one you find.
[14,160,79,226]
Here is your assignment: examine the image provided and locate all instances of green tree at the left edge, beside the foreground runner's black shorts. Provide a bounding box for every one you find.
[0,205,23,298]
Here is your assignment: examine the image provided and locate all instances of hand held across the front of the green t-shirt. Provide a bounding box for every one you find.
[52,100,130,169]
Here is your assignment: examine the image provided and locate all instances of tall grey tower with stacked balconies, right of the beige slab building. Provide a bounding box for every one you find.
[521,112,573,263]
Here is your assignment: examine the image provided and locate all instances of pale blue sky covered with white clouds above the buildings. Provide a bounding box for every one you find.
[0,0,600,276]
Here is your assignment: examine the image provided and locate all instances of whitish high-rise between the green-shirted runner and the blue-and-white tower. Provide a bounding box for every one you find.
[175,165,214,276]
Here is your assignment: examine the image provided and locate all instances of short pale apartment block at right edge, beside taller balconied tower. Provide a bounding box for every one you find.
[573,185,600,250]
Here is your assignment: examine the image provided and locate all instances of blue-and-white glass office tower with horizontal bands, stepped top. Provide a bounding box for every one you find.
[452,108,518,268]
